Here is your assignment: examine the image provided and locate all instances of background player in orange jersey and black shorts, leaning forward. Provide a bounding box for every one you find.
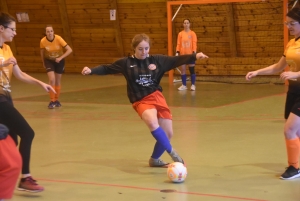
[40,25,72,109]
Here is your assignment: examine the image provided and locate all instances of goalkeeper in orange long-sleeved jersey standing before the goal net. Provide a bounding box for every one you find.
[176,19,197,91]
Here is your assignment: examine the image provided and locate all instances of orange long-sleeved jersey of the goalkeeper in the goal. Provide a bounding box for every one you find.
[176,30,197,55]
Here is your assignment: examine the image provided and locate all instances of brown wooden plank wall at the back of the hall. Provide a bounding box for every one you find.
[6,0,284,75]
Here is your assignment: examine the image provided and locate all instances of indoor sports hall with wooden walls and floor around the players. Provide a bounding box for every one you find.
[0,0,300,201]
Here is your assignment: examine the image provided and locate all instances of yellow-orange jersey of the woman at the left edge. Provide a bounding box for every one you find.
[0,44,13,94]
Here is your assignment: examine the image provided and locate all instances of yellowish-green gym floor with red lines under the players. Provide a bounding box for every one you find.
[8,73,300,201]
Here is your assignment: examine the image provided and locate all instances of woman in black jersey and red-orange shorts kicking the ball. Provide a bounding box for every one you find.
[82,34,208,167]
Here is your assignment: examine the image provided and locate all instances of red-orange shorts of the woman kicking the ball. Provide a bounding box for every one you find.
[132,90,172,119]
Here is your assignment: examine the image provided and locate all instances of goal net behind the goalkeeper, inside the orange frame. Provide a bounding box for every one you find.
[171,0,288,84]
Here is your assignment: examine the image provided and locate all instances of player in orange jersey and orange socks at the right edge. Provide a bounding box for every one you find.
[246,8,300,179]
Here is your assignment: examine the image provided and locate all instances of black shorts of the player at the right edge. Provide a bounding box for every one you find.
[284,91,300,119]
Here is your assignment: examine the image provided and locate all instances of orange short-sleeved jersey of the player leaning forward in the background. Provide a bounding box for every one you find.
[40,35,68,60]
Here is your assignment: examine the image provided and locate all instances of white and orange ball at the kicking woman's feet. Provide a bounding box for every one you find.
[167,162,187,183]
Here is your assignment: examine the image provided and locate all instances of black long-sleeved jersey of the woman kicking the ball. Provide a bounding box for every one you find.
[91,54,196,103]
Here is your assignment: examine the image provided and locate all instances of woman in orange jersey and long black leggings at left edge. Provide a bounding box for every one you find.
[0,12,55,192]
